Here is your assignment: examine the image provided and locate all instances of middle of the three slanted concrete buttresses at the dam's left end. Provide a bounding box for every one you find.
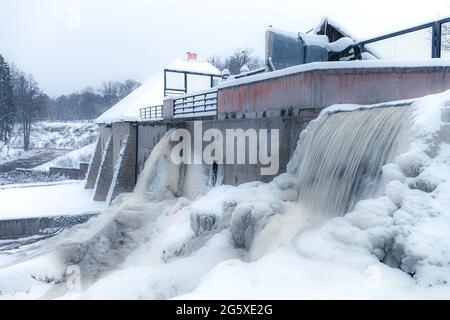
[94,136,114,201]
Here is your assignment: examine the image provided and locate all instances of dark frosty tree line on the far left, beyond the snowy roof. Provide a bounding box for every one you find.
[0,54,140,151]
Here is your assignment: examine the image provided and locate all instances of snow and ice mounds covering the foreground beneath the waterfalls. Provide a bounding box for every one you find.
[0,92,450,299]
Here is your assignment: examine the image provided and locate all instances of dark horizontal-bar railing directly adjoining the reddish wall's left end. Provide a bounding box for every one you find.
[173,90,217,117]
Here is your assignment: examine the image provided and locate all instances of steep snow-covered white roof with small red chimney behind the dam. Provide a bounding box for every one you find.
[95,58,221,124]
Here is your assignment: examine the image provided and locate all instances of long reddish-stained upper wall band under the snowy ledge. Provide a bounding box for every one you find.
[218,66,450,114]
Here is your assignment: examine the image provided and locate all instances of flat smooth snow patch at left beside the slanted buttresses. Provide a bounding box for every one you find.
[0,181,105,220]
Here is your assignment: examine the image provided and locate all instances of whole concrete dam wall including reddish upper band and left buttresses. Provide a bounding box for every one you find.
[87,61,450,201]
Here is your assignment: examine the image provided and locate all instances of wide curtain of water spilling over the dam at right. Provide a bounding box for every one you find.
[296,106,408,217]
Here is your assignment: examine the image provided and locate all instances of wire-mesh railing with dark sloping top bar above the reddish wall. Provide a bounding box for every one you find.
[359,18,450,60]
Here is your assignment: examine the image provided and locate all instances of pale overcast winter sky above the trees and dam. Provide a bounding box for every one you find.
[0,0,450,96]
